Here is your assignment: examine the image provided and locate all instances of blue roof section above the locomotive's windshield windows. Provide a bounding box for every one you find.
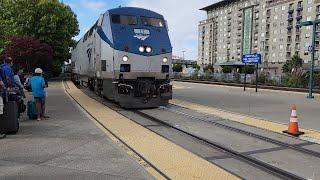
[108,7,163,19]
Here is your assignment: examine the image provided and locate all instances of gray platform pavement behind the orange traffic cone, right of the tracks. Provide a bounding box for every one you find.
[173,82,320,130]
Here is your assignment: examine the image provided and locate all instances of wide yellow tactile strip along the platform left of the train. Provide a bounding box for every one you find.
[67,82,239,179]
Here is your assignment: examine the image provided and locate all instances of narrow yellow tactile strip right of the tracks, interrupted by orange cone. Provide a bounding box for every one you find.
[170,99,320,142]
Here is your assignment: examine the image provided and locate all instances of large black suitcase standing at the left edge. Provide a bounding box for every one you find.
[0,101,19,134]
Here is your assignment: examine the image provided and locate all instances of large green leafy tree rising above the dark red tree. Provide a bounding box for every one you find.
[0,0,79,74]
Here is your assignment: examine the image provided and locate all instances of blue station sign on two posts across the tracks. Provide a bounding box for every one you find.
[242,54,262,92]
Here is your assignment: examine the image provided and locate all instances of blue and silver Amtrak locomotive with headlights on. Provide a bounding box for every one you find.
[71,7,172,108]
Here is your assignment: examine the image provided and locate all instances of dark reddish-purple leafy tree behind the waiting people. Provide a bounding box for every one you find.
[5,36,53,71]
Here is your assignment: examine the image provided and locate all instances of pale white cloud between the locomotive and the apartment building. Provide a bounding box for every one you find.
[127,0,217,60]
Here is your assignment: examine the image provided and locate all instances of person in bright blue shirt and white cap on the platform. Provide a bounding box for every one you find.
[29,68,46,121]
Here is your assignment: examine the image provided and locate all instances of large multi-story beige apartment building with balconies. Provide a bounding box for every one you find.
[198,0,320,74]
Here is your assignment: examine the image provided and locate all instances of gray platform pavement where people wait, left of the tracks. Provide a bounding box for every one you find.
[0,82,153,179]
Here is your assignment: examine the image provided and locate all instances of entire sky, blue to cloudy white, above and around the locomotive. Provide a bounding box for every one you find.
[61,0,217,60]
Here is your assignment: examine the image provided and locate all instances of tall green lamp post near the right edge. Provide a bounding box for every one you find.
[301,19,320,99]
